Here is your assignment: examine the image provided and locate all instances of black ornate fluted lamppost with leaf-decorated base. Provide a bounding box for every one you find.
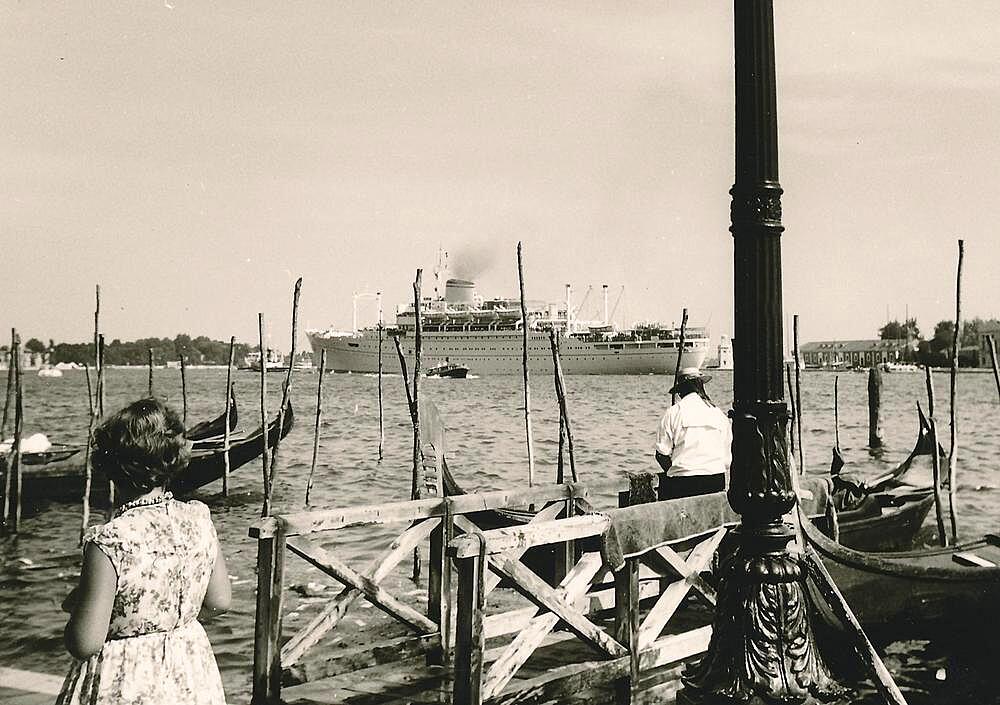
[677,0,841,704]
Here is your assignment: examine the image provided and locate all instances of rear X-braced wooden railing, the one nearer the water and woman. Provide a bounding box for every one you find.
[250,470,656,703]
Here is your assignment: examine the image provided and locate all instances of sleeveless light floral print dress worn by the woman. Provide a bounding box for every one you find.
[56,499,225,705]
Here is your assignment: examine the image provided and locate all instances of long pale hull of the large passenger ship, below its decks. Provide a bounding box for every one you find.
[308,330,708,375]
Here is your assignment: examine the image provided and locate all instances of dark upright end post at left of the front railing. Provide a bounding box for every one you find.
[454,554,486,705]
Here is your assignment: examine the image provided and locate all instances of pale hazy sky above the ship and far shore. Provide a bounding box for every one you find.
[0,0,1000,349]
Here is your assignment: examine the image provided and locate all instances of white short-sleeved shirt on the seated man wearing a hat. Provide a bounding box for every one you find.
[656,392,733,476]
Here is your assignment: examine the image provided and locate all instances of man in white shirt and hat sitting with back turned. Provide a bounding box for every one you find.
[656,367,733,499]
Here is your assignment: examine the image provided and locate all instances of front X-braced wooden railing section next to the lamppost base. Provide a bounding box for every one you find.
[448,504,727,705]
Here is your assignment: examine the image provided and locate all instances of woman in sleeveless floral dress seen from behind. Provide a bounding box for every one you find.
[56,399,231,705]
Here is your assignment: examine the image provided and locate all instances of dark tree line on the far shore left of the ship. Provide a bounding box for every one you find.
[0,333,256,365]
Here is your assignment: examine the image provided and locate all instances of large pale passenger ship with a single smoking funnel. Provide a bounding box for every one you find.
[306,256,709,375]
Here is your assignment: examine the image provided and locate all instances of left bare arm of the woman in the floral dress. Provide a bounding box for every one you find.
[63,543,118,659]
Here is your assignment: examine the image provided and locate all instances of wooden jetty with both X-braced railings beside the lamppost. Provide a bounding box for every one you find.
[250,456,726,705]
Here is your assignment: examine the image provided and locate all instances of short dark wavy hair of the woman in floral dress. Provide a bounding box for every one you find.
[91,399,191,493]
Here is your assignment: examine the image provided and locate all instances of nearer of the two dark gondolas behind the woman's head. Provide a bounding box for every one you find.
[21,403,295,502]
